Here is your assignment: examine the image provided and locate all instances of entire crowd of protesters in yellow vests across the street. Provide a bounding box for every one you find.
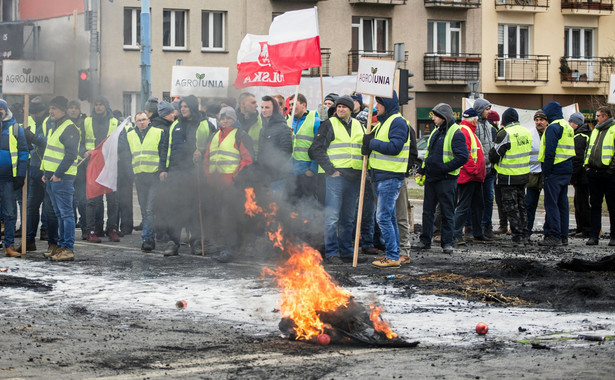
[0,92,615,268]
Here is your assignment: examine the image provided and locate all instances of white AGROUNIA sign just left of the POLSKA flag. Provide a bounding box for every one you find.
[171,66,229,98]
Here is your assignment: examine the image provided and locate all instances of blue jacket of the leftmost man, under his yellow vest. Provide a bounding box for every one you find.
[0,113,30,182]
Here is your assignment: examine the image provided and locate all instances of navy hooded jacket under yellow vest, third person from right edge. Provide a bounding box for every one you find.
[542,102,572,179]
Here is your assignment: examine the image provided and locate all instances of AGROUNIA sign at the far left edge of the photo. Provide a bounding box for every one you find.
[2,59,56,94]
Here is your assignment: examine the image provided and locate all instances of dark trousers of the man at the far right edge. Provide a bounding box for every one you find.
[587,170,615,238]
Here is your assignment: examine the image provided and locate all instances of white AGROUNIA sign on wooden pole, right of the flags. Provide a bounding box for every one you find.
[356,58,396,98]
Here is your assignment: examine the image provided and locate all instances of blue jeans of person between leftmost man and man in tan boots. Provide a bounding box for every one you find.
[26,169,58,244]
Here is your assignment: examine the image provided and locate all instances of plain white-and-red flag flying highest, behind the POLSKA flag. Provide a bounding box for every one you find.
[269,7,321,73]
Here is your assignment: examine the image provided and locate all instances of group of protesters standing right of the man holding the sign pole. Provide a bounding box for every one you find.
[412,99,615,253]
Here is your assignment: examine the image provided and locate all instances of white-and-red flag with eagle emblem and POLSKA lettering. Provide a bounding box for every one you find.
[233,34,301,88]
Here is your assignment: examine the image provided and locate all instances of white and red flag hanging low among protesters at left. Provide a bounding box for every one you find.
[85,117,130,199]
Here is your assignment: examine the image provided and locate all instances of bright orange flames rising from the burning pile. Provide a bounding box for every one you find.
[245,188,397,340]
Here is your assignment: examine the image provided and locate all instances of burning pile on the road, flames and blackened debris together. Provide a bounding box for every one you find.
[245,188,418,346]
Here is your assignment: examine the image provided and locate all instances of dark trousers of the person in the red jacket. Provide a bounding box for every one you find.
[455,181,484,238]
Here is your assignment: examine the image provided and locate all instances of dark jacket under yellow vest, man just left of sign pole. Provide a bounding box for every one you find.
[308,115,361,181]
